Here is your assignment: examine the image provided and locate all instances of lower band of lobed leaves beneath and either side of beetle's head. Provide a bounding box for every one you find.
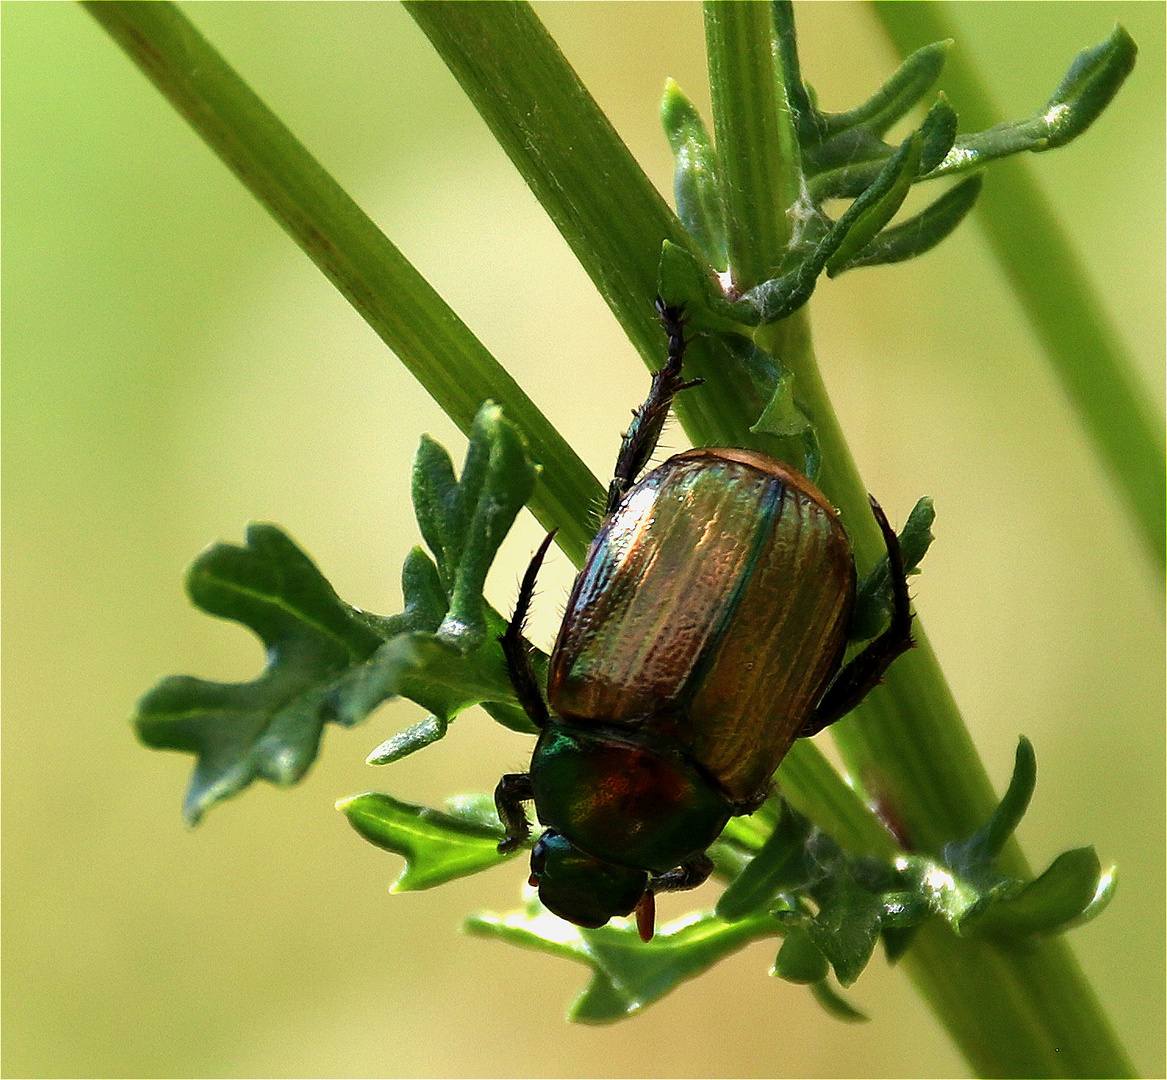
[352,739,1114,1023]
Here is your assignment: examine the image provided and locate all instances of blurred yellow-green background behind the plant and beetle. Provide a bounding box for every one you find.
[2,2,1165,1076]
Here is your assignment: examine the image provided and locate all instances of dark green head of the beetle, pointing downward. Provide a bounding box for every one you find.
[531,829,649,929]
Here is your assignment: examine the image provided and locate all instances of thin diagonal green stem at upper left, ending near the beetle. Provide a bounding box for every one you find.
[84,0,603,562]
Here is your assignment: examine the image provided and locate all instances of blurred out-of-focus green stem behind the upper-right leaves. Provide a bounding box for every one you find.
[874,0,1167,573]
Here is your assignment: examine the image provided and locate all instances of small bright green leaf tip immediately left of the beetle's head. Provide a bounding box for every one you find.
[336,792,513,892]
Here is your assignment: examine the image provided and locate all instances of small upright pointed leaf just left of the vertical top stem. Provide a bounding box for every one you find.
[661,78,729,271]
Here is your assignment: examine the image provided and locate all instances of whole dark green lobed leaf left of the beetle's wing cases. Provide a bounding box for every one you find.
[135,402,536,824]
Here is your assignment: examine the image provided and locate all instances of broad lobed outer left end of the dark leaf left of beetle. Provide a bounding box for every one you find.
[135,524,382,824]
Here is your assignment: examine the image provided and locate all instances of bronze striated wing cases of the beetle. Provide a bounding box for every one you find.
[548,450,854,802]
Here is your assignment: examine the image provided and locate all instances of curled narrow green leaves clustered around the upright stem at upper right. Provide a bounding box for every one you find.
[662,4,1137,327]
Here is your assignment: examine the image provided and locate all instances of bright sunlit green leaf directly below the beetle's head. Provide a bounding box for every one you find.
[466,898,777,1024]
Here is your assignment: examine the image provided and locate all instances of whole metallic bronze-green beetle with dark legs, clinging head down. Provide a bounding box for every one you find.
[495,299,913,941]
